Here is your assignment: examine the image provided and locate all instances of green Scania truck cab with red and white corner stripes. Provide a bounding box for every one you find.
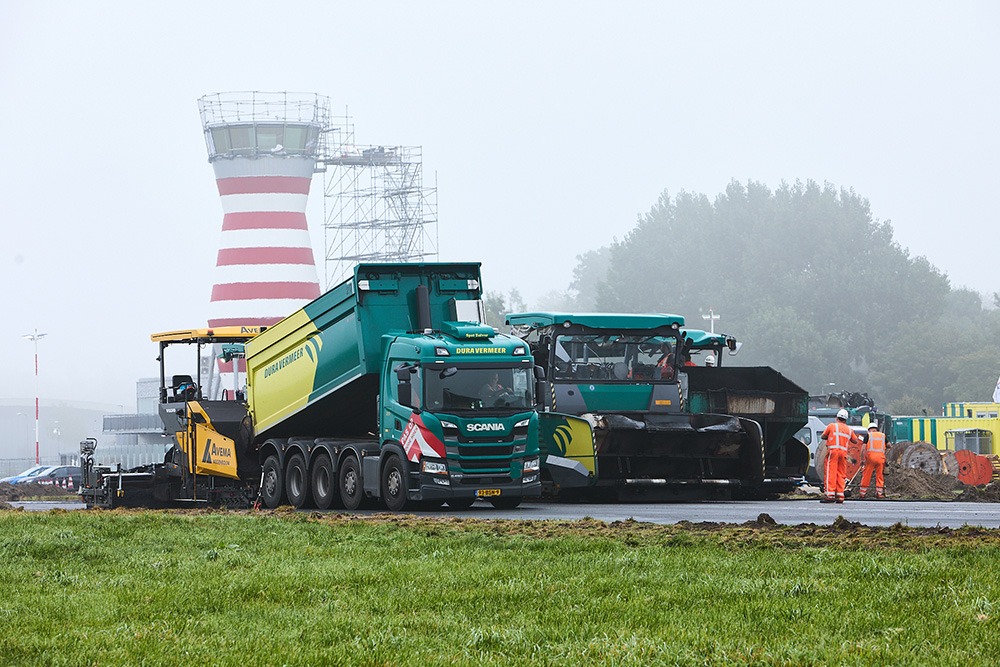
[376,322,541,508]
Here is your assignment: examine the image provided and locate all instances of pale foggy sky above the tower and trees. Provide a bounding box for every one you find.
[0,0,1000,411]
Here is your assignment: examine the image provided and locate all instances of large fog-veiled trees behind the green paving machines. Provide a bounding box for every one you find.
[489,181,1000,414]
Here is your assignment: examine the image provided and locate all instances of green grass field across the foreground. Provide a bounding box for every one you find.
[0,511,1000,666]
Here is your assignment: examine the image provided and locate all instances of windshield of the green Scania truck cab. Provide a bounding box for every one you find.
[424,366,535,412]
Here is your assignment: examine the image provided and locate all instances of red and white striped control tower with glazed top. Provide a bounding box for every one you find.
[198,92,330,396]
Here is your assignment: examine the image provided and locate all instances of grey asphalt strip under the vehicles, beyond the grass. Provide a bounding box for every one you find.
[11,499,1000,528]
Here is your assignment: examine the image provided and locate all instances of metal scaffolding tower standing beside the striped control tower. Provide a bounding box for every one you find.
[317,115,438,289]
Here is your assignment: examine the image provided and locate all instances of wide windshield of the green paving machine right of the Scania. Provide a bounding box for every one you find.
[552,334,677,381]
